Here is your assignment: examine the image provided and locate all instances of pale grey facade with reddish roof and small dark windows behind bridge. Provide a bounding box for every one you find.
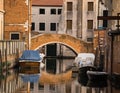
[32,0,63,34]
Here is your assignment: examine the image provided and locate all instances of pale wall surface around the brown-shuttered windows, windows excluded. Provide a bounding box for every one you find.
[59,0,98,41]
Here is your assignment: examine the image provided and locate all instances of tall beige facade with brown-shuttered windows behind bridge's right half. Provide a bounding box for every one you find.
[58,0,106,42]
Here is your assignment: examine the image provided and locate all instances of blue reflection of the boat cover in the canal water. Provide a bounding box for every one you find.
[21,74,40,83]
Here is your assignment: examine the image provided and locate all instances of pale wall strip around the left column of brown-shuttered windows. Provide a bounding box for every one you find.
[58,0,78,37]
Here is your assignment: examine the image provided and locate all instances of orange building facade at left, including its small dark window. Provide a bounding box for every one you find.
[4,0,31,48]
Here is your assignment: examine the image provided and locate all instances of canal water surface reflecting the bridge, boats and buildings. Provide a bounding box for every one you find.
[0,58,120,93]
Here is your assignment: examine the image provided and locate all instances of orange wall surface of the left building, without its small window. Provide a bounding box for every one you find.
[4,0,31,40]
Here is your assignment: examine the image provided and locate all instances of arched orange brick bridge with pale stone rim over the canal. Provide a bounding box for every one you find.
[30,34,93,54]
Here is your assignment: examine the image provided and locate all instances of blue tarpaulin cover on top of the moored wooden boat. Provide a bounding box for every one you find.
[19,50,41,61]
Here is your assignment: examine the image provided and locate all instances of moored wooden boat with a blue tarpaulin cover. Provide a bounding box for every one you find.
[19,50,43,67]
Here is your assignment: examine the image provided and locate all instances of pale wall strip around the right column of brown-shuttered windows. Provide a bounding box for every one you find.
[82,0,98,41]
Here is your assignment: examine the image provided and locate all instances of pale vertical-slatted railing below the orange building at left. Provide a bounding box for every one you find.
[0,40,25,56]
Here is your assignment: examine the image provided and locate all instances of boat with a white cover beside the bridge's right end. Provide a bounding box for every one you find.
[74,53,96,76]
